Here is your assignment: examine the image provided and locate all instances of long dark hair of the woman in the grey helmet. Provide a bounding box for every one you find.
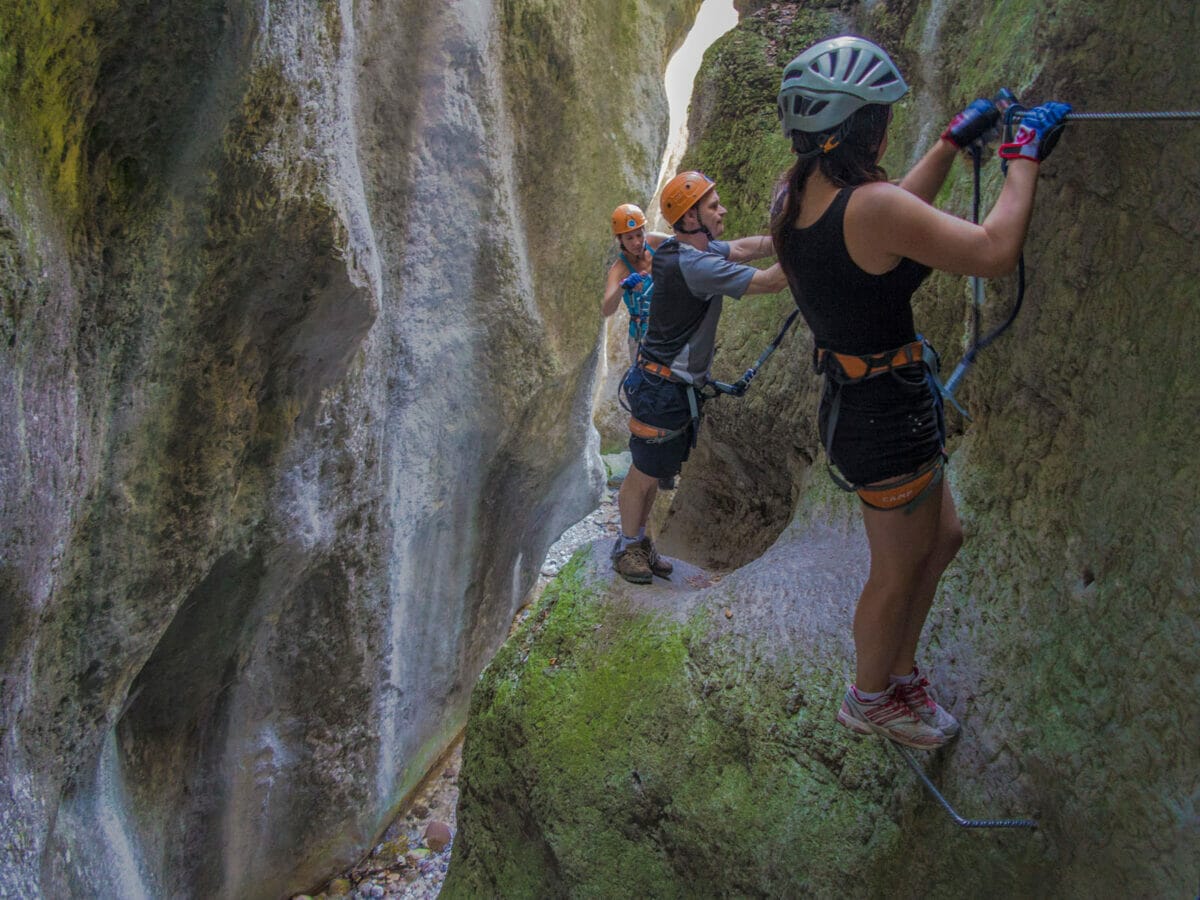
[770,103,889,264]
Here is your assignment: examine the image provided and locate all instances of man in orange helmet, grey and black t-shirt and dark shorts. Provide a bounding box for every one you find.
[612,172,787,584]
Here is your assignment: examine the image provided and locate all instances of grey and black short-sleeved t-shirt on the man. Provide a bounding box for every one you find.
[643,239,757,386]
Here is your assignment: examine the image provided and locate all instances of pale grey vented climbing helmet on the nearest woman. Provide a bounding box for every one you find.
[779,36,908,137]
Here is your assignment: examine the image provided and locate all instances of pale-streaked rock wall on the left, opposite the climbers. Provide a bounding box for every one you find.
[0,0,697,898]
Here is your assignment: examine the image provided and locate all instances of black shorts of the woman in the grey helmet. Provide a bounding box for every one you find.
[817,365,946,485]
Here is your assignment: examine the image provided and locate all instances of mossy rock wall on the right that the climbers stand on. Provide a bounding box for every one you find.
[445,0,1200,896]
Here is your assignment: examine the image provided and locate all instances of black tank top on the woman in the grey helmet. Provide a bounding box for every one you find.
[779,187,929,355]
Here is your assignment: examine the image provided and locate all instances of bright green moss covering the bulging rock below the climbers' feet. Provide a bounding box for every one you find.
[445,554,1003,896]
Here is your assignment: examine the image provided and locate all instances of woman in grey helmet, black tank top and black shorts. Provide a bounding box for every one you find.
[772,37,1069,749]
